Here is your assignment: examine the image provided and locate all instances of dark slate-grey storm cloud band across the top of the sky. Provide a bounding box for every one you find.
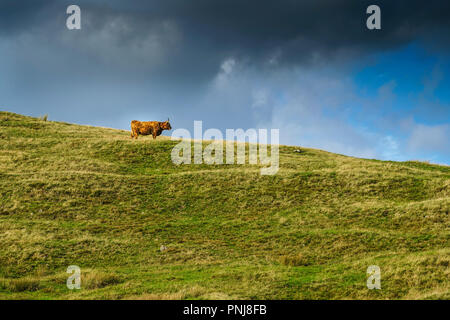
[0,0,450,80]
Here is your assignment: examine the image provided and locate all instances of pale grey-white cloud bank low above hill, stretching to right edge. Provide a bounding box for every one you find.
[203,58,450,162]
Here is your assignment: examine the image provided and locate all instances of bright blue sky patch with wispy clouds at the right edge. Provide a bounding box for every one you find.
[350,43,450,164]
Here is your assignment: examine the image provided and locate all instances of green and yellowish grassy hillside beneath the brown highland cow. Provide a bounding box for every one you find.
[0,112,450,299]
